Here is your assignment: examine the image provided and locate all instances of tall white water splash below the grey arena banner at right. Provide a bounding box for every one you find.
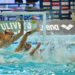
[43,35,75,64]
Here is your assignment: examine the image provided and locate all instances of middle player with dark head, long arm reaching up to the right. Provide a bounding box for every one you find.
[15,26,40,52]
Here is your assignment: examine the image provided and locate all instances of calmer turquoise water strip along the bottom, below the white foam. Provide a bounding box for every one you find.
[0,62,75,75]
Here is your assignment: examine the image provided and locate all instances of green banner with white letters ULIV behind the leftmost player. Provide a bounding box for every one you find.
[0,21,20,32]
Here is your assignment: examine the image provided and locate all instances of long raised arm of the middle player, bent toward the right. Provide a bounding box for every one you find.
[16,26,39,52]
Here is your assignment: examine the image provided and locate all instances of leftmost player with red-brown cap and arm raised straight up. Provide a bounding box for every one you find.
[0,20,24,47]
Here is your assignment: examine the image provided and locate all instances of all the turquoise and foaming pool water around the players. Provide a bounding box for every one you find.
[0,35,75,75]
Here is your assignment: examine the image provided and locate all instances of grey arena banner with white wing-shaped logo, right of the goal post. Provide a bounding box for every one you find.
[40,20,75,35]
